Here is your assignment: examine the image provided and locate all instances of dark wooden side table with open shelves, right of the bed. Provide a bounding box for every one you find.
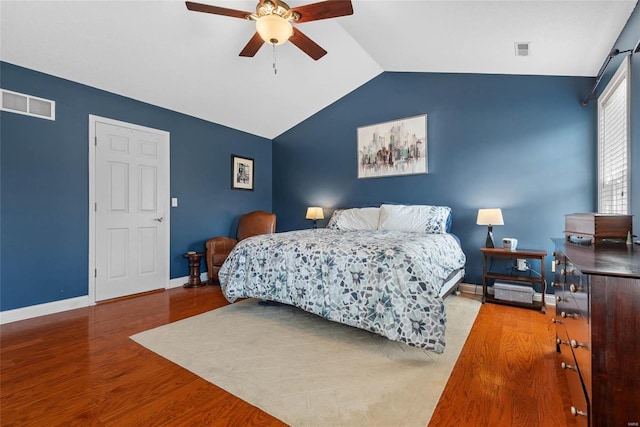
[480,248,547,313]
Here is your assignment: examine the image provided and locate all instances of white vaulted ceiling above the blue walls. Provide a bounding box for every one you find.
[0,0,636,139]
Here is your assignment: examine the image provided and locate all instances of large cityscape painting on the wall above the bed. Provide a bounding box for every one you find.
[358,114,428,178]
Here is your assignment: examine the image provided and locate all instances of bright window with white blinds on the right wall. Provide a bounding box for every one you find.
[598,57,630,214]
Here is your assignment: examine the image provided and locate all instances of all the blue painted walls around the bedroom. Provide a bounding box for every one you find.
[0,6,640,310]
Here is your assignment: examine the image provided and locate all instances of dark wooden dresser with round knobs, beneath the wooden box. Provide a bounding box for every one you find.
[552,239,640,427]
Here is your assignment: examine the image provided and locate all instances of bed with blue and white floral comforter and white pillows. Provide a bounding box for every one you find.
[219,204,466,353]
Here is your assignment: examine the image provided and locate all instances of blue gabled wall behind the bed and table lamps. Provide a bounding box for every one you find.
[273,72,596,283]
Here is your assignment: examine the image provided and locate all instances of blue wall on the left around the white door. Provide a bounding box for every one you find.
[0,62,272,310]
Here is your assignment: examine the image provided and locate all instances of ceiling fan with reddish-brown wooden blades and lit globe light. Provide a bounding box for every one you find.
[186,0,353,61]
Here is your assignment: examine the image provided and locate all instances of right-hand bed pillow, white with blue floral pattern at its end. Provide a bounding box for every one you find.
[378,204,451,234]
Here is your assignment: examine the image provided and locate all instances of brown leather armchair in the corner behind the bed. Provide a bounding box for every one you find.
[205,211,276,285]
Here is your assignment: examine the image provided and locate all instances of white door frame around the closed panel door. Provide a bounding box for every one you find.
[88,114,171,305]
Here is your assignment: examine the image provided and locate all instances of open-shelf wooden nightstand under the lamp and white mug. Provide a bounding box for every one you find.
[480,248,547,313]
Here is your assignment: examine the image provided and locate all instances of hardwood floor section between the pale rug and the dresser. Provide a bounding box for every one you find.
[429,303,576,427]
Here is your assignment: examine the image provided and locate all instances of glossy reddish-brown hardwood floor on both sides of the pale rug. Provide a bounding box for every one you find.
[0,286,573,426]
